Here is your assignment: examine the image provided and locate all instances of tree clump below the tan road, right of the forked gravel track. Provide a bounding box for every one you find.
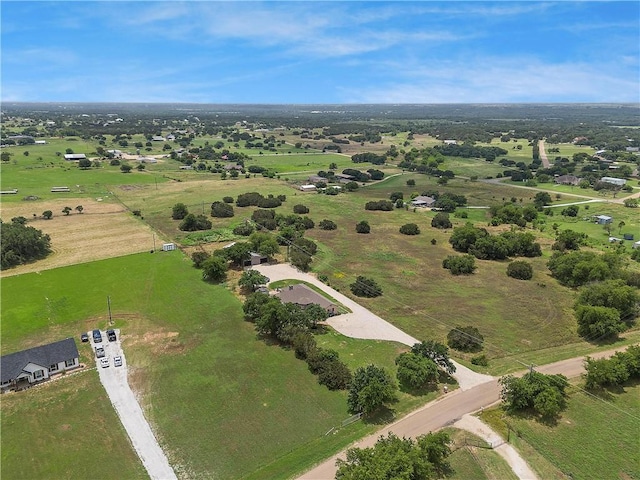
[499,371,569,418]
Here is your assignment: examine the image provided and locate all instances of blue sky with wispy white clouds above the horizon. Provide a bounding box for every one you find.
[1,1,640,103]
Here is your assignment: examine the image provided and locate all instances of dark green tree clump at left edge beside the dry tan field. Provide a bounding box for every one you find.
[0,217,51,270]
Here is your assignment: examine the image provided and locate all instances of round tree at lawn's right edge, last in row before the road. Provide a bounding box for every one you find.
[347,365,398,415]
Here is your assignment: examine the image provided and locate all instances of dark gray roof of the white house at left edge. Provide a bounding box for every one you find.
[0,338,79,383]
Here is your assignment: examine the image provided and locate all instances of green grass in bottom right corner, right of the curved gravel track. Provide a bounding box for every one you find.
[483,383,640,480]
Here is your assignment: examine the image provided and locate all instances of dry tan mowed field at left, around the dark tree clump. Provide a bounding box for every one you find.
[1,198,162,277]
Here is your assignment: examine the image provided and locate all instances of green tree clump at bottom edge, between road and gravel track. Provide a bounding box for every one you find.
[336,432,451,480]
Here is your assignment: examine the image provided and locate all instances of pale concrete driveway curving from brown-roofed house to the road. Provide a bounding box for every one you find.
[253,263,493,390]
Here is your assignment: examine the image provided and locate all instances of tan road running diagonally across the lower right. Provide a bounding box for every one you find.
[298,344,632,480]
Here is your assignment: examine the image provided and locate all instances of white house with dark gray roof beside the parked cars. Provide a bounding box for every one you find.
[0,338,80,393]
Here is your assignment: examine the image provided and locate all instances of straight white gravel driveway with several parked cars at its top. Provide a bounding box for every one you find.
[89,330,177,480]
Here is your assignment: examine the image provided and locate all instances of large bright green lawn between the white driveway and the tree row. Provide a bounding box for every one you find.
[1,251,421,479]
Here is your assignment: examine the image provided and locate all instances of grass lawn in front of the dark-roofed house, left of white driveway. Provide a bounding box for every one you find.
[0,370,149,480]
